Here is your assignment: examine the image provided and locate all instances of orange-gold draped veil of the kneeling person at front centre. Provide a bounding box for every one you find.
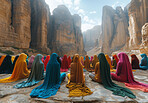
[66,54,92,97]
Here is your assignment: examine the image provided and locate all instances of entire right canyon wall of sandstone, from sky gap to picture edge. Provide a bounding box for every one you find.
[86,0,148,54]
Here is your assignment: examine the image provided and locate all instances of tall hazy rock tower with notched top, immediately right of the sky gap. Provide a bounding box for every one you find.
[99,6,129,54]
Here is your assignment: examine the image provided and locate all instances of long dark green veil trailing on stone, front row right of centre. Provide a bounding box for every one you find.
[98,53,136,98]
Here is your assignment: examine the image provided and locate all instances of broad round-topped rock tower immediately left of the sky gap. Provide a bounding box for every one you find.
[48,5,84,56]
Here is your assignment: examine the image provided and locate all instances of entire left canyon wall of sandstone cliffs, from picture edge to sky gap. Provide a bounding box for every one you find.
[0,0,85,56]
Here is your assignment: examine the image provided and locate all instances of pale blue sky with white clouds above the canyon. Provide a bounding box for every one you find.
[45,0,131,32]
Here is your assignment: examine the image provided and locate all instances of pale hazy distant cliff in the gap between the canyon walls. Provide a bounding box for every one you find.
[83,25,102,51]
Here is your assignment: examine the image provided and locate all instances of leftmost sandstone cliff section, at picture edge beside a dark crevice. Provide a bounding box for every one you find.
[0,0,19,46]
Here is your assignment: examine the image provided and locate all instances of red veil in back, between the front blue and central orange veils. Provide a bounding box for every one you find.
[61,55,69,72]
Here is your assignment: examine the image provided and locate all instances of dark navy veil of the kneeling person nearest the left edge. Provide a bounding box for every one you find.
[0,55,13,74]
